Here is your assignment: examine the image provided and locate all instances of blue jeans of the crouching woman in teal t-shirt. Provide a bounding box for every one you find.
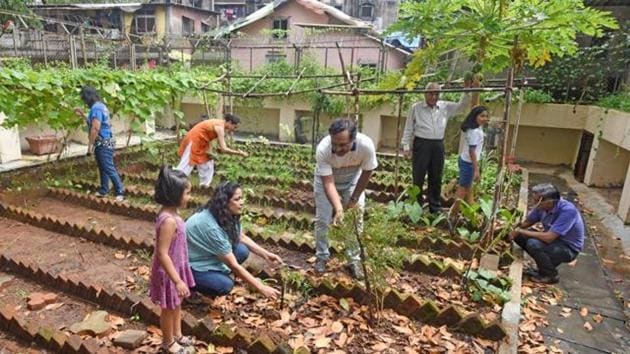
[192,243,249,296]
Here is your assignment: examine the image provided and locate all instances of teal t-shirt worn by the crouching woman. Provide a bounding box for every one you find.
[186,209,241,273]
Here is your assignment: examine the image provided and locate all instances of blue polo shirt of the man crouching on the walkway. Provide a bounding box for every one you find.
[527,199,586,252]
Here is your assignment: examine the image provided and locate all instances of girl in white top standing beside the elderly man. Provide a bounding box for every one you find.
[454,106,489,206]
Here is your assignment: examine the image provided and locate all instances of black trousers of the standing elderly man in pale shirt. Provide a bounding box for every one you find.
[412,138,444,212]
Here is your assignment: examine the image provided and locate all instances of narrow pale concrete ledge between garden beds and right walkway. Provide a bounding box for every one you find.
[499,169,529,354]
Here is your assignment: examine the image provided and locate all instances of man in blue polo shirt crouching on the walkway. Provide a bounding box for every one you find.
[509,183,585,284]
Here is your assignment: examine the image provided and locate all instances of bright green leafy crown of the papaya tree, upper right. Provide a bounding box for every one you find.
[388,0,618,103]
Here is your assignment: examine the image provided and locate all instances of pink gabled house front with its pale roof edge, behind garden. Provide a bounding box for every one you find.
[218,0,410,71]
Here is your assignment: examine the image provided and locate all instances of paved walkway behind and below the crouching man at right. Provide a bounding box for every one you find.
[530,168,630,354]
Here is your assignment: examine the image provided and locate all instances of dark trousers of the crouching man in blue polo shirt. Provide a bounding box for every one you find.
[514,235,579,277]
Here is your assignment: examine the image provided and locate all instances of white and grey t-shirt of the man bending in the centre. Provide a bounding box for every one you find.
[315,133,378,186]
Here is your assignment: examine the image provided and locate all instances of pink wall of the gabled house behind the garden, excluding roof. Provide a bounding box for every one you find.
[232,1,406,70]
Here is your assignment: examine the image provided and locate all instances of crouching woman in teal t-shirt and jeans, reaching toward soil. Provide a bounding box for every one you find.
[186,182,282,298]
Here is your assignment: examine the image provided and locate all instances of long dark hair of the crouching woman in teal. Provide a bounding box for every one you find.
[203,182,241,247]
